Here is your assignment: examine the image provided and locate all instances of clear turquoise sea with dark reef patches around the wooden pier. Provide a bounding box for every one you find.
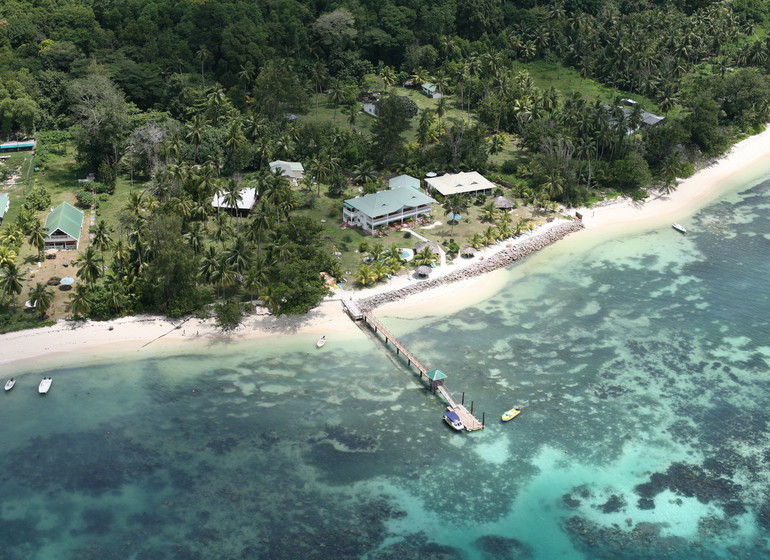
[0,164,770,560]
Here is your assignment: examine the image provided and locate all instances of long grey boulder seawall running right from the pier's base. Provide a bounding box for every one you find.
[358,220,583,312]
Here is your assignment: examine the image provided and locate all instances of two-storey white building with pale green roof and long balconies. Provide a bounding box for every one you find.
[342,187,436,233]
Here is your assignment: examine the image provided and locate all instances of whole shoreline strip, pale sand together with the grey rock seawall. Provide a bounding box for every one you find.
[0,129,770,365]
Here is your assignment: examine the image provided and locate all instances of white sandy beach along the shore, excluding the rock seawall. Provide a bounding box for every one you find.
[0,129,770,363]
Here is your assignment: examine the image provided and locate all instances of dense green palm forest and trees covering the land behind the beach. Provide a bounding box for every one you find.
[0,0,770,323]
